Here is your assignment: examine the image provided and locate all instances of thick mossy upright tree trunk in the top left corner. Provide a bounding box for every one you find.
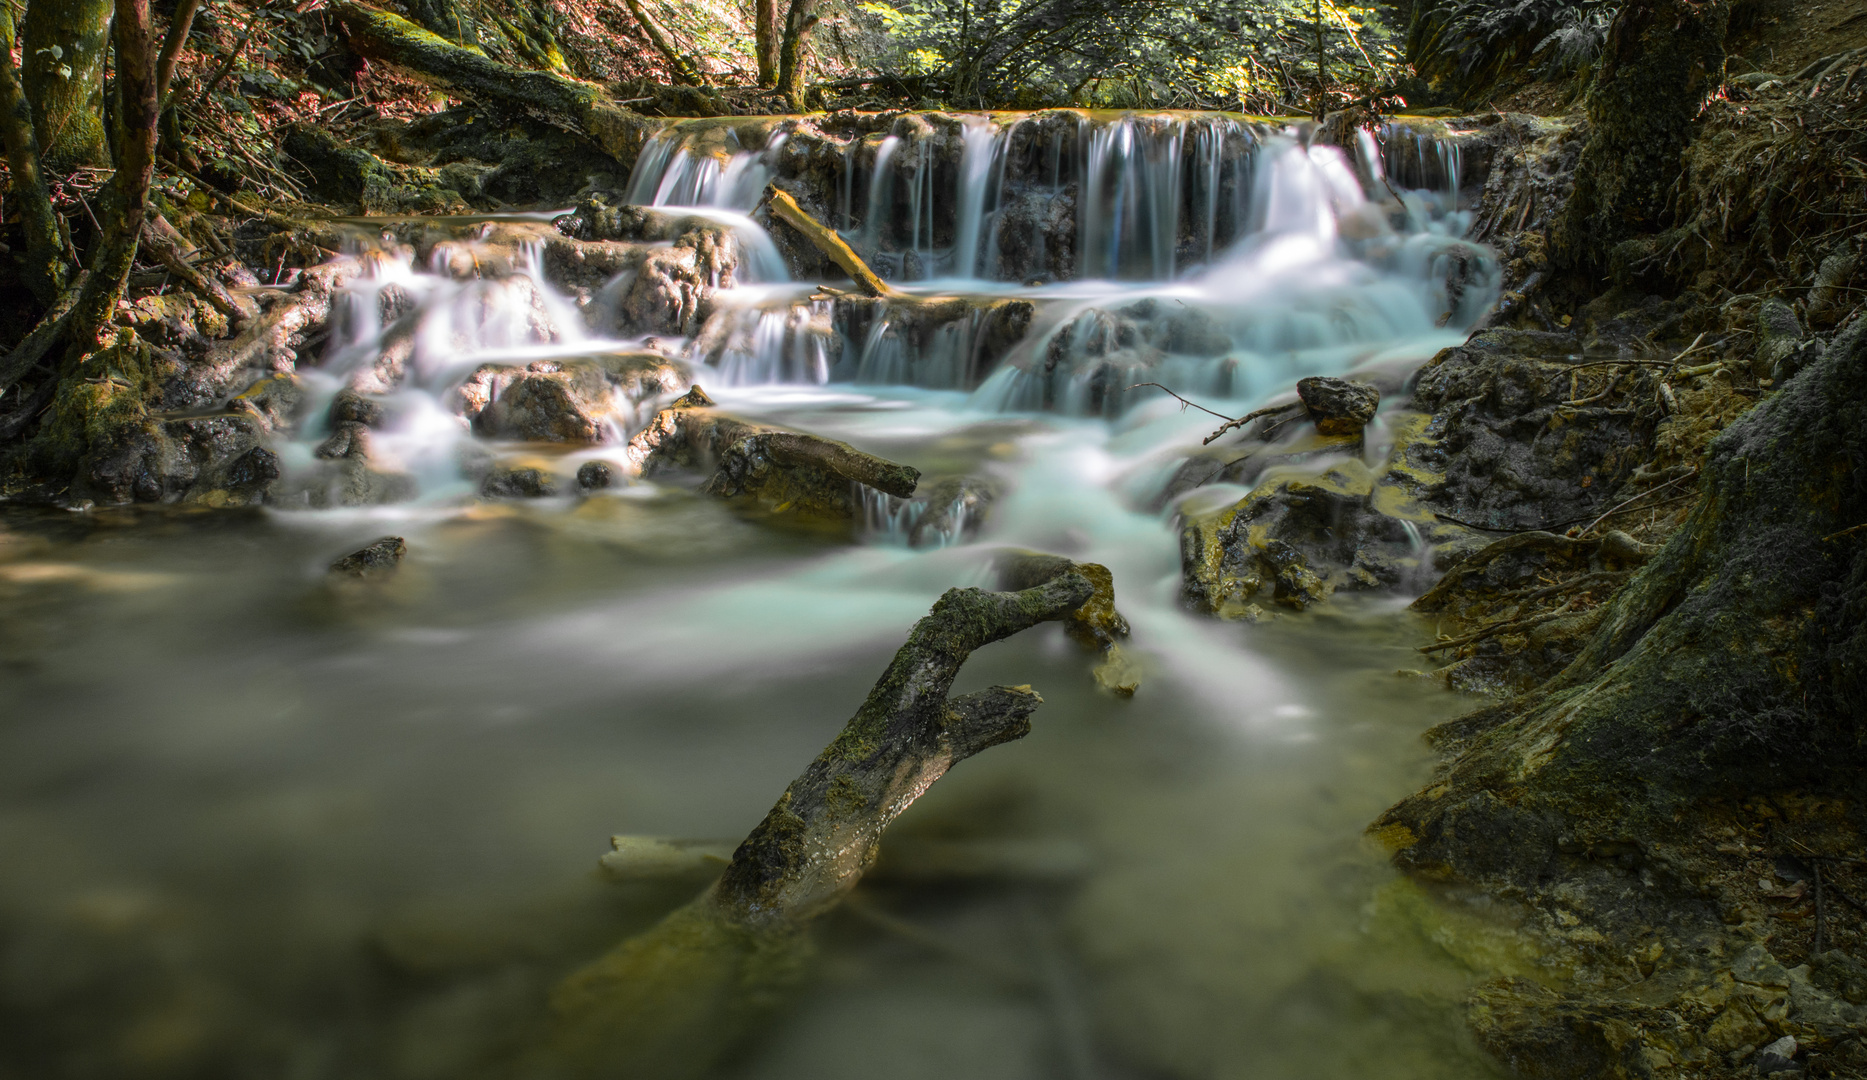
[21,0,110,172]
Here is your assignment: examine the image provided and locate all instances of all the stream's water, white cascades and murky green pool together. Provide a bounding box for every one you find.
[0,118,1509,1080]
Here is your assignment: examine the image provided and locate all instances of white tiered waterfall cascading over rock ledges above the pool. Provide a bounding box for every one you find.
[280,112,1495,536]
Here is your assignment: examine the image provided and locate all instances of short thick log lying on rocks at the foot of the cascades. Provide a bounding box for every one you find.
[624,387,920,518]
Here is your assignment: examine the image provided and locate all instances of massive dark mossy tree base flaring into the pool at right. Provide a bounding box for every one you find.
[1374,320,1867,902]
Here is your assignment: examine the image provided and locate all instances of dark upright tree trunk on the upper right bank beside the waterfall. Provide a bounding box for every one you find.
[1555,0,1731,275]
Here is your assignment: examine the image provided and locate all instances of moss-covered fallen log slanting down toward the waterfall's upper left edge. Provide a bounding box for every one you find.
[330,0,659,164]
